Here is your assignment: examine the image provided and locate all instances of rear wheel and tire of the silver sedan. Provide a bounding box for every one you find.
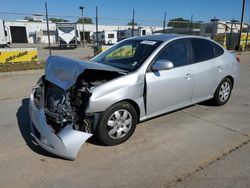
[212,78,233,106]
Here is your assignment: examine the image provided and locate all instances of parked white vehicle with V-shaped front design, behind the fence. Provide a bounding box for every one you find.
[56,23,78,48]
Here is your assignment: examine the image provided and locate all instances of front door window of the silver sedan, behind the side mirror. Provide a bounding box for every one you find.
[155,39,189,67]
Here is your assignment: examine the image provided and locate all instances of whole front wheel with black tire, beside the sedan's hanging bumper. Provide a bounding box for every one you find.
[96,102,138,146]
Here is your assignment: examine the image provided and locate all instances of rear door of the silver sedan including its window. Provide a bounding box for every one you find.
[191,38,222,103]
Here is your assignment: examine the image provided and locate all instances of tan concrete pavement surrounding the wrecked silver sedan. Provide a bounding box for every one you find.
[0,54,250,188]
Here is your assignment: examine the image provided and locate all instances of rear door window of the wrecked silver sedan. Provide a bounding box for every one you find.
[191,39,215,63]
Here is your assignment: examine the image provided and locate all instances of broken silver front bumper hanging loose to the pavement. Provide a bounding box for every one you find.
[29,91,92,160]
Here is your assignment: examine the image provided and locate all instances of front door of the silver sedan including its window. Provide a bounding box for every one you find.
[146,39,194,118]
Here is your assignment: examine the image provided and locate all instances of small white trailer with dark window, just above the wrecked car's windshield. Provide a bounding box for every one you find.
[93,31,117,45]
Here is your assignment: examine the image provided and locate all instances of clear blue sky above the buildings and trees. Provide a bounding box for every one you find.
[0,0,250,25]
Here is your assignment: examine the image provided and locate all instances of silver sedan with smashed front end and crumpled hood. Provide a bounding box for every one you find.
[30,35,239,159]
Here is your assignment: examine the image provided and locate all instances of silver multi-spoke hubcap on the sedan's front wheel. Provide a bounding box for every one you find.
[107,110,132,139]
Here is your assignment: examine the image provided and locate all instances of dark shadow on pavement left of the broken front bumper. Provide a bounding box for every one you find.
[16,98,62,159]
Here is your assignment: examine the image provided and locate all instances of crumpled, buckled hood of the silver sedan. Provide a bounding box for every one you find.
[45,56,124,90]
